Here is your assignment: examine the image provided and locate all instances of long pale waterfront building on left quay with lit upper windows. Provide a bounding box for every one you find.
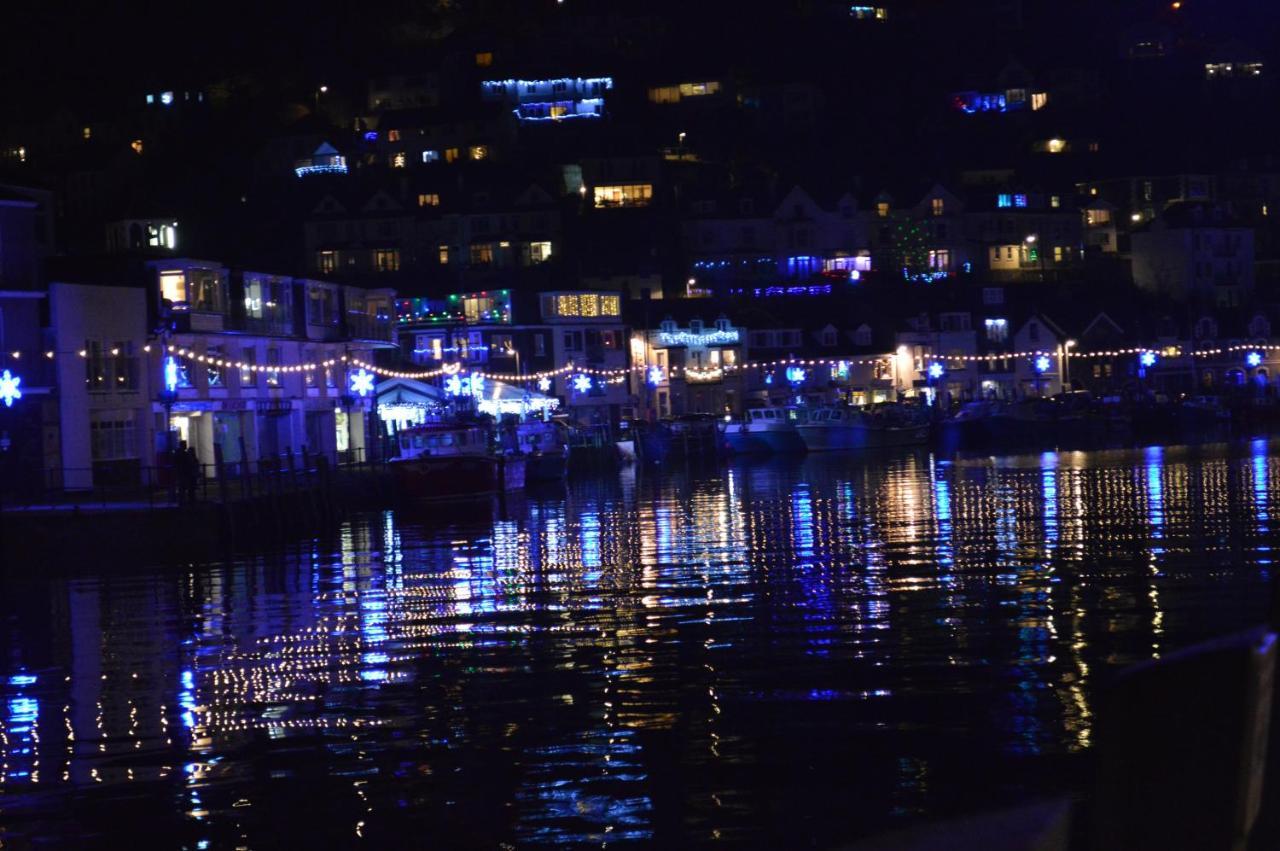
[50,257,393,488]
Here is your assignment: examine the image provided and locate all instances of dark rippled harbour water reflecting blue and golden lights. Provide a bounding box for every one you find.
[0,441,1280,851]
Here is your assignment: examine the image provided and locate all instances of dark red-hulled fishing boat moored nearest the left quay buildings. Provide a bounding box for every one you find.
[390,422,525,499]
